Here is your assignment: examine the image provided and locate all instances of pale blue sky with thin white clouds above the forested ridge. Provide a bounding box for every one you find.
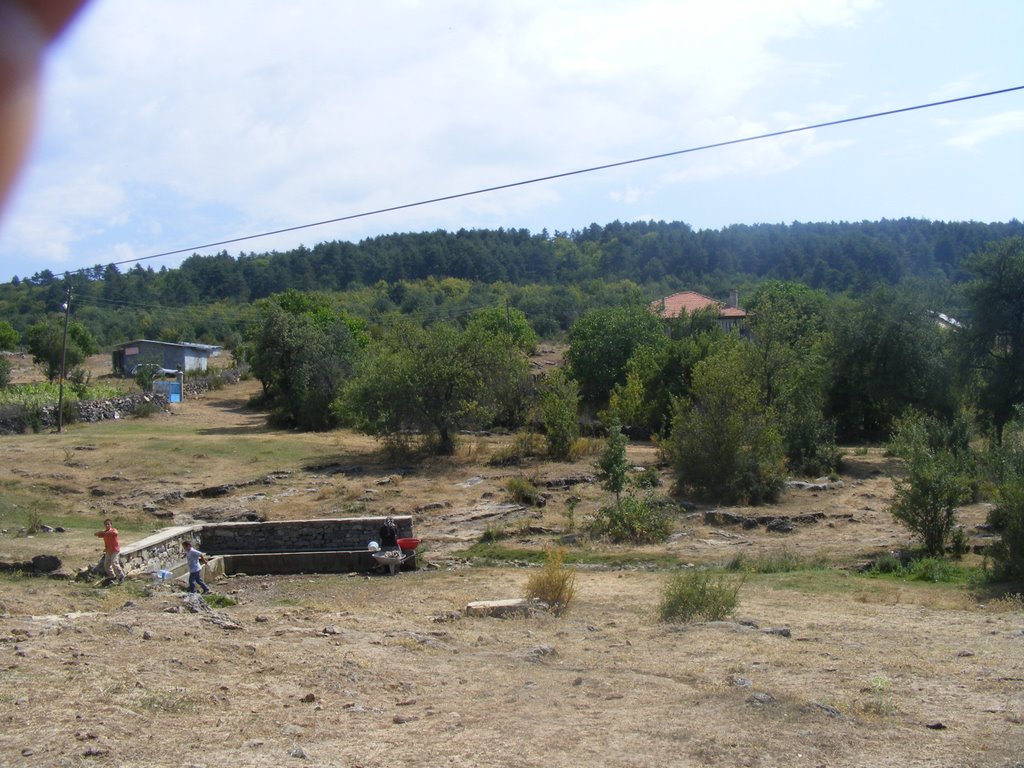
[0,0,1024,281]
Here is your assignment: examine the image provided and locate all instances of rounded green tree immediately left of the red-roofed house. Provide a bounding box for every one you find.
[565,304,666,406]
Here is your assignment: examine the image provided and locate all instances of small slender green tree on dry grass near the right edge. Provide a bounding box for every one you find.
[890,413,971,557]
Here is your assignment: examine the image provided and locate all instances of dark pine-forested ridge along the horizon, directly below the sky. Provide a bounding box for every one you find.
[0,218,1024,348]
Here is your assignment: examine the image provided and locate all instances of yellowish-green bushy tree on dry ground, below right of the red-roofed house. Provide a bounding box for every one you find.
[669,339,785,504]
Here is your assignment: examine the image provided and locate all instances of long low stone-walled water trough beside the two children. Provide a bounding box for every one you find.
[121,516,416,579]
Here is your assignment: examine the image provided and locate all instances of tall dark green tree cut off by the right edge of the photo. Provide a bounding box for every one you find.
[961,238,1024,441]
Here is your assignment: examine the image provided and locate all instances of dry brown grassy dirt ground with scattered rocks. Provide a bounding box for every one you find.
[0,361,1024,768]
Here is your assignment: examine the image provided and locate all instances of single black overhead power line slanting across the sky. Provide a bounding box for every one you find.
[75,85,1024,271]
